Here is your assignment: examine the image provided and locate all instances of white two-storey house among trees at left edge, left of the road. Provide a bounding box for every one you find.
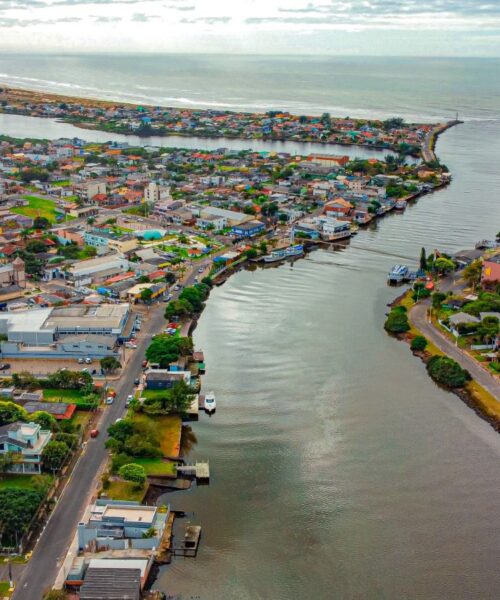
[0,422,52,475]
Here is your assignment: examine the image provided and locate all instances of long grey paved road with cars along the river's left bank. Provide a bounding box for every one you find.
[13,261,210,600]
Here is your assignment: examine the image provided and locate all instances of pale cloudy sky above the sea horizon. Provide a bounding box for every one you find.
[0,0,500,56]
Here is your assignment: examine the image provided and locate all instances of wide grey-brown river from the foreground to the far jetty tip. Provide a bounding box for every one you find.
[155,121,500,600]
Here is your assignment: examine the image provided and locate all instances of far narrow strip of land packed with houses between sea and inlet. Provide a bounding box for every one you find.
[0,87,457,157]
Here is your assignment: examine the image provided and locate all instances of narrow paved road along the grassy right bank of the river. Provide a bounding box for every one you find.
[409,301,500,401]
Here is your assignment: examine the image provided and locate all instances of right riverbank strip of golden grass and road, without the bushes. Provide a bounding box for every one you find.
[390,290,500,433]
